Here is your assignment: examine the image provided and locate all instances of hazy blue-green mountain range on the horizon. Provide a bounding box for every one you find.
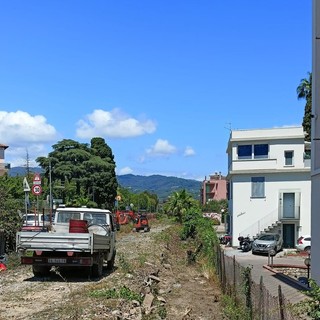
[9,167,202,201]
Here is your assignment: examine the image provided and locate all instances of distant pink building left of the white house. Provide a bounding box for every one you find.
[201,172,227,205]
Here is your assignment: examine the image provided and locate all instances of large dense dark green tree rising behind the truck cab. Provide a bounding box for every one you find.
[36,138,118,209]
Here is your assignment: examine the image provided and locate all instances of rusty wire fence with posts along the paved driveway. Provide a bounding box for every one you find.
[216,246,310,320]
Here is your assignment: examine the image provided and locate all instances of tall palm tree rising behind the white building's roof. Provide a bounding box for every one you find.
[297,72,312,141]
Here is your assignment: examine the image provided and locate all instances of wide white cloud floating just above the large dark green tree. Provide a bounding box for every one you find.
[76,109,156,139]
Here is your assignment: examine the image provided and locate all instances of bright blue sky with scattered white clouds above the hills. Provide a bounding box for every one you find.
[0,0,312,180]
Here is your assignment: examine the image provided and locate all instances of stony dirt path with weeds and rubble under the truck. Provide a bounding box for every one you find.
[0,226,223,320]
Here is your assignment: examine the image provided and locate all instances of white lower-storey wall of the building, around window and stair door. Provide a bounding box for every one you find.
[232,173,311,245]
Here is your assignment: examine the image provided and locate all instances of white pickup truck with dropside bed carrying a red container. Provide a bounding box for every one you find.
[16,207,116,277]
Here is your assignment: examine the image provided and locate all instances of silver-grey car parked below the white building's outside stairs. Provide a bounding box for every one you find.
[252,233,283,256]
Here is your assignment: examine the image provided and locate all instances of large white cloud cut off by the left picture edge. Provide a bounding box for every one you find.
[0,111,57,146]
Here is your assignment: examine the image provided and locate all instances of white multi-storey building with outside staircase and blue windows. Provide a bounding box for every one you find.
[227,127,311,248]
